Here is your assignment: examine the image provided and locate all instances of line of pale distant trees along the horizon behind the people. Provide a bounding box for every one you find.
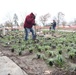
[0,12,76,27]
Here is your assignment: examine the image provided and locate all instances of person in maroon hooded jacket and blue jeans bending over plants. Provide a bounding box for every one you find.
[24,13,36,40]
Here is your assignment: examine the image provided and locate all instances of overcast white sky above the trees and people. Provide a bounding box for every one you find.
[0,0,76,24]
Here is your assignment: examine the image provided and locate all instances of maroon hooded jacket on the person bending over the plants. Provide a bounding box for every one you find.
[24,13,35,28]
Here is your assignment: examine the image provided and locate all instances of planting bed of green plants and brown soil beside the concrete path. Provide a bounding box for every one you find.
[0,31,76,75]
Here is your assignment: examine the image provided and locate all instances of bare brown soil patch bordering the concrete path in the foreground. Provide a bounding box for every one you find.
[0,44,53,75]
